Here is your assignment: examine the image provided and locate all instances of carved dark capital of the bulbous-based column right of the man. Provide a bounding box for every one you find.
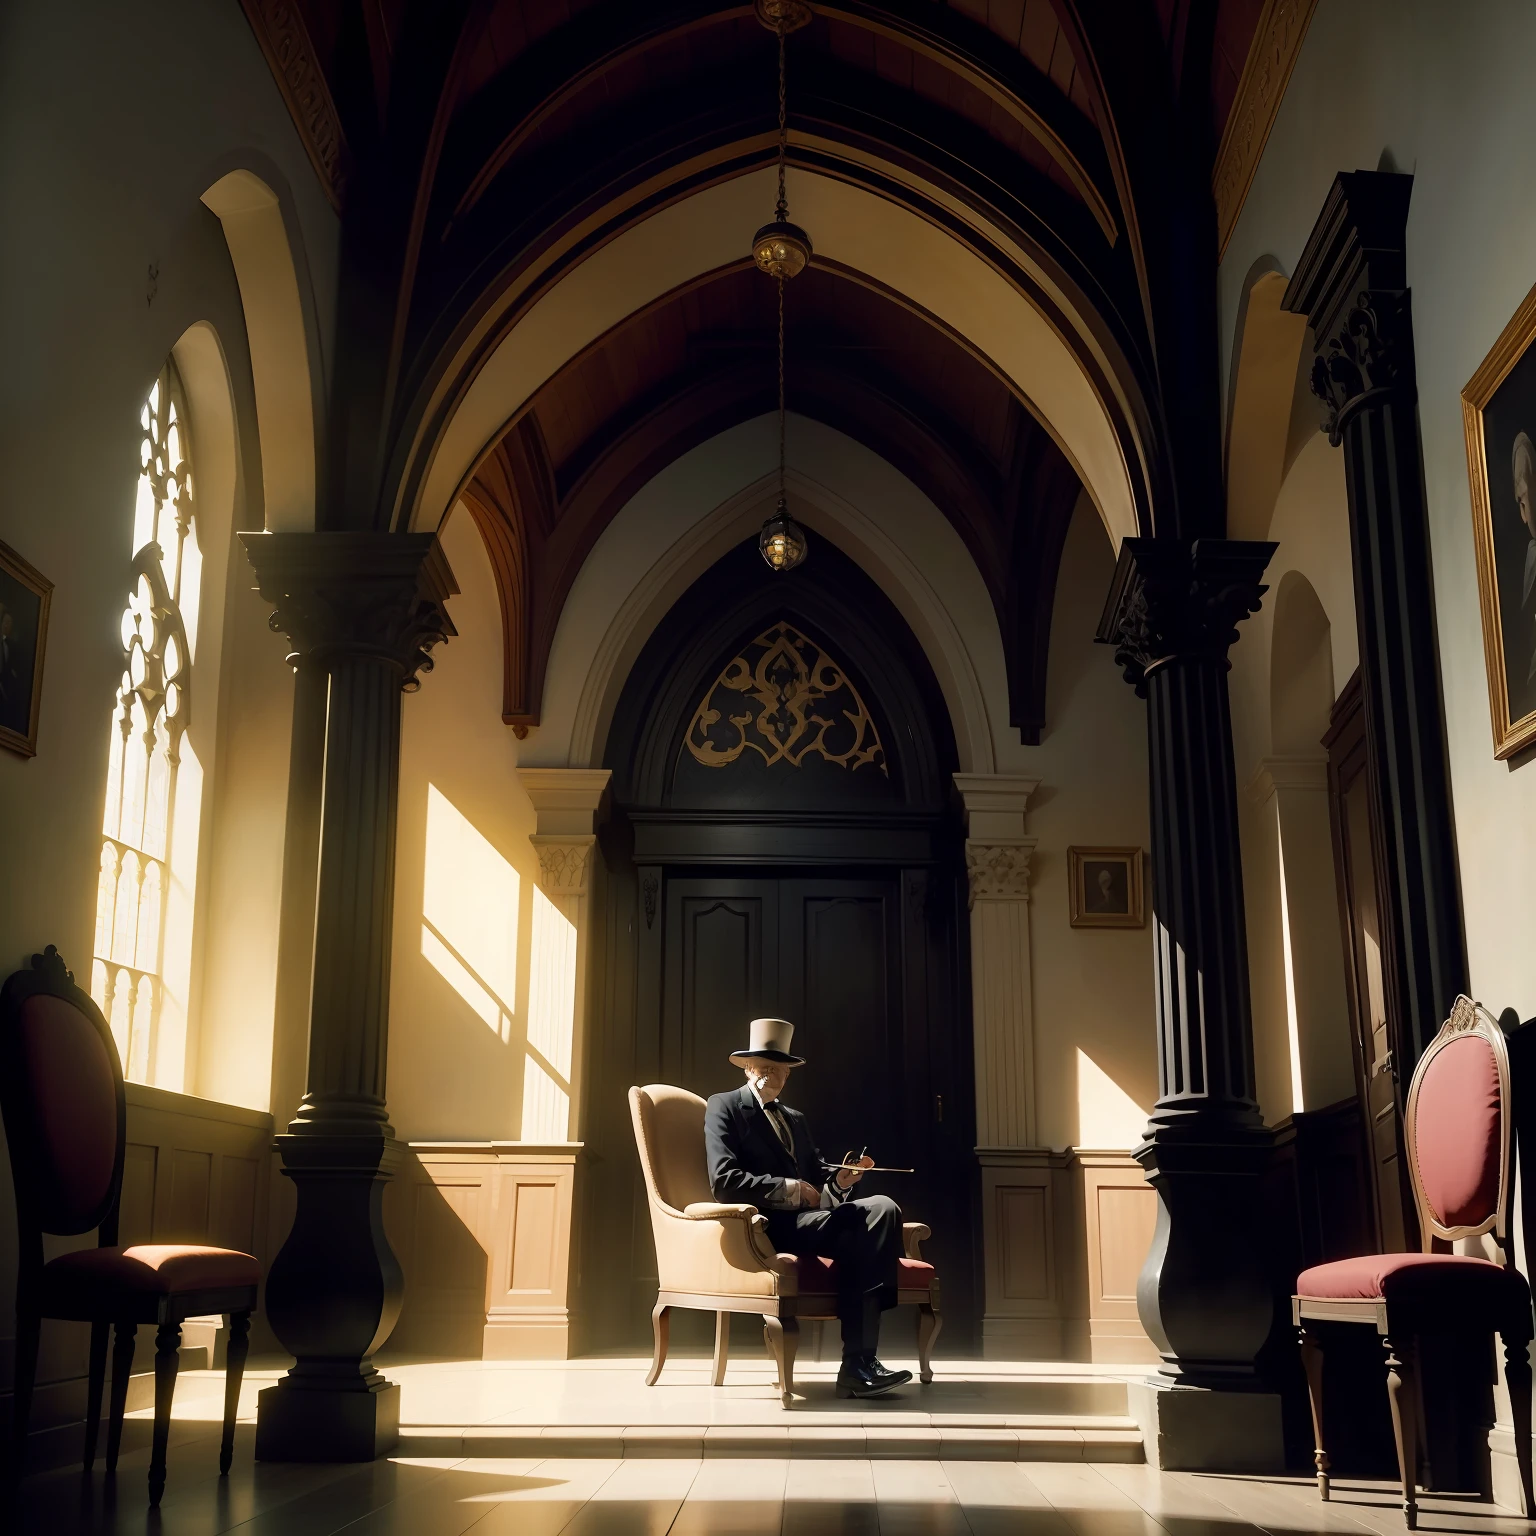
[1097,538,1276,699]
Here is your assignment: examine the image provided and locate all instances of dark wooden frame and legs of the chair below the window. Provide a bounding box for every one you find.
[0,945,257,1505]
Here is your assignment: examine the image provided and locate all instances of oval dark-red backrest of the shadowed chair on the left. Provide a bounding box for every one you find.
[0,945,127,1243]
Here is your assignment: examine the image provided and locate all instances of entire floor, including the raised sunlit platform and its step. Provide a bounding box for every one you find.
[14,1359,1536,1536]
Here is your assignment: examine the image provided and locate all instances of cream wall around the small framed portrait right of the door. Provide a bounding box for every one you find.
[1021,501,1158,1149]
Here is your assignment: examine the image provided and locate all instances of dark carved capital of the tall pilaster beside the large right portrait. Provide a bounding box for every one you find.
[1281,170,1415,447]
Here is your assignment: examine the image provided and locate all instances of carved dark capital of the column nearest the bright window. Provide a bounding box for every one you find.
[240,531,459,691]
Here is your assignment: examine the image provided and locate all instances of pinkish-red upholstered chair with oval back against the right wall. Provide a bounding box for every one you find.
[1290,997,1531,1530]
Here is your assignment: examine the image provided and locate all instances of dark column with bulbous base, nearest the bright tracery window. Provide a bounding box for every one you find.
[241,533,458,1461]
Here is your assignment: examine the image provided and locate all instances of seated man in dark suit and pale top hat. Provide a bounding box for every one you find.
[703,1018,912,1398]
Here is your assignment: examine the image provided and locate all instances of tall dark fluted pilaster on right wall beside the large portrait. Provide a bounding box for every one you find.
[1283,170,1467,1069]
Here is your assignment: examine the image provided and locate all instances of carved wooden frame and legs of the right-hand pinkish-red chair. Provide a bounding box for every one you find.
[1290,997,1533,1530]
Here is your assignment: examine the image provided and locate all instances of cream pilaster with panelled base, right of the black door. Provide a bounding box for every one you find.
[955,773,1063,1359]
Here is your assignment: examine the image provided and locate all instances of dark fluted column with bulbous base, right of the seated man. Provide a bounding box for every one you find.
[1098,538,1284,1471]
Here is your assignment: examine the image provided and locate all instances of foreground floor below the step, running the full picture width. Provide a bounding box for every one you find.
[12,1427,1531,1536]
